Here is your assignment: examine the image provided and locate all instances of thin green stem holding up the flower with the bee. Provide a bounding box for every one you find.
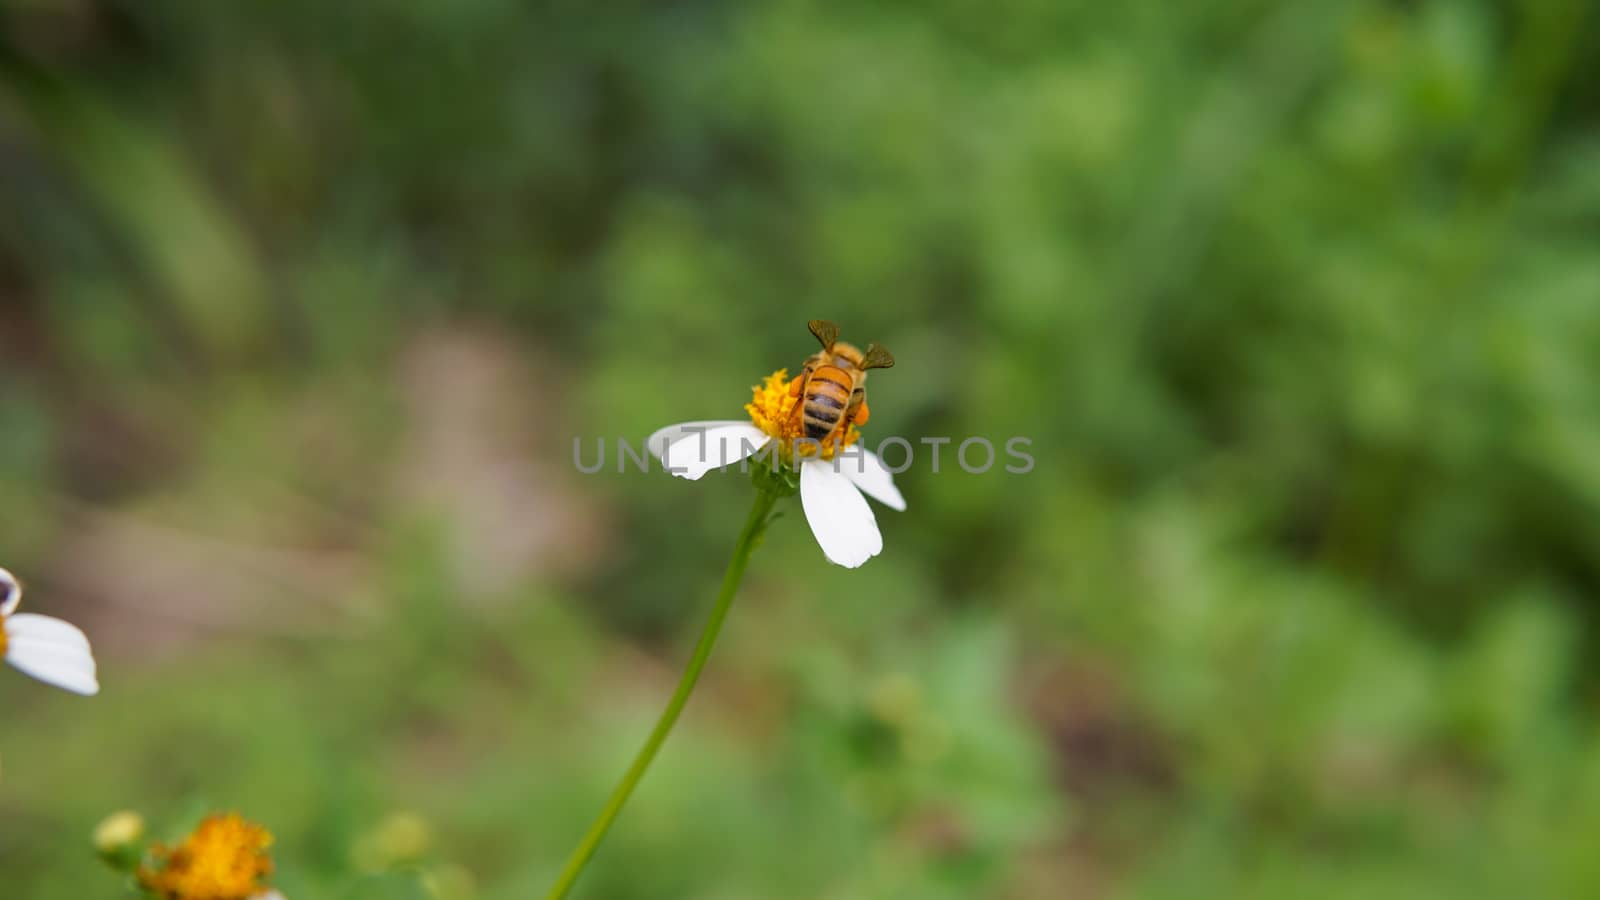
[546,490,779,900]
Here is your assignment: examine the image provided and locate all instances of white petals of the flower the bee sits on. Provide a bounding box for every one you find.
[650,421,906,569]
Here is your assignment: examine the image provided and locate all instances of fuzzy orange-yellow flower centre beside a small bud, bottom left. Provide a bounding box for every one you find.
[139,814,272,900]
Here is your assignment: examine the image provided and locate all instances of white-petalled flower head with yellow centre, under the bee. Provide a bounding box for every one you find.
[648,370,906,569]
